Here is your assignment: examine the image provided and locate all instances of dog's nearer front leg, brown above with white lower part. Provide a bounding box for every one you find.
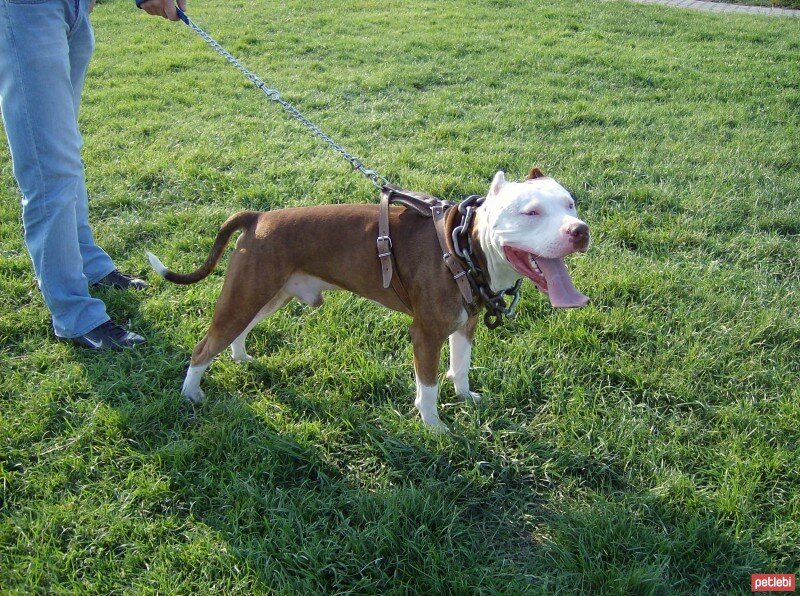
[410,323,449,432]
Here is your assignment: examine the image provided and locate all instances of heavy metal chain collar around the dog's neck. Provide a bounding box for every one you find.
[452,195,522,329]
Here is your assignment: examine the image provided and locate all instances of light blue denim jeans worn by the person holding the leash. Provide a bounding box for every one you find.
[0,0,114,337]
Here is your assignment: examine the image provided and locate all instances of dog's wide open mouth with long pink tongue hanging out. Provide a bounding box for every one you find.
[503,246,589,308]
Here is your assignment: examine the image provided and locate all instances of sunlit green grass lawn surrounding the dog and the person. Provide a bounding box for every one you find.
[0,0,800,594]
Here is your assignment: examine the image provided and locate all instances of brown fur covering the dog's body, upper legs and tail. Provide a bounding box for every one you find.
[159,205,477,385]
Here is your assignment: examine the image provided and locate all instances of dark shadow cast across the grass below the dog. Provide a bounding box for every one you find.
[75,300,761,593]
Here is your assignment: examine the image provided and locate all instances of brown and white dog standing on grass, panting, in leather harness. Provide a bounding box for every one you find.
[147,168,589,430]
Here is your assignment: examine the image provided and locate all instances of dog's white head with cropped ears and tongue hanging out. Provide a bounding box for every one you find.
[476,168,589,308]
